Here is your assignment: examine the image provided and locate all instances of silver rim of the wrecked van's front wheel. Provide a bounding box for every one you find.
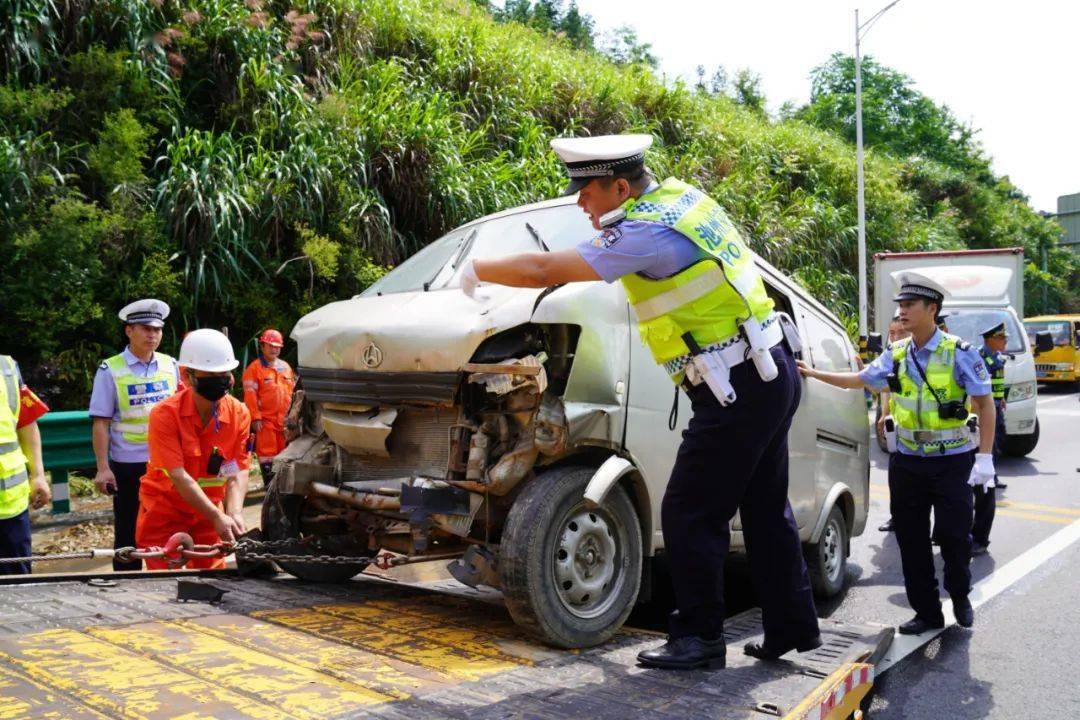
[552,505,626,619]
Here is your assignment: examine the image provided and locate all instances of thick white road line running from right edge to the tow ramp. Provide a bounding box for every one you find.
[876,520,1080,674]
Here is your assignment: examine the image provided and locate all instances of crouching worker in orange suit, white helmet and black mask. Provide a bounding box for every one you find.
[135,329,252,570]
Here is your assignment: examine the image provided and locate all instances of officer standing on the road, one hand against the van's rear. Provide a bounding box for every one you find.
[799,271,994,635]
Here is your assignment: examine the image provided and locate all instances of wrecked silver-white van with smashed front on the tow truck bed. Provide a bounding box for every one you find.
[262,199,870,648]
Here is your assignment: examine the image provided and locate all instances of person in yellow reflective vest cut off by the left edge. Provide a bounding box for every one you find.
[0,355,50,574]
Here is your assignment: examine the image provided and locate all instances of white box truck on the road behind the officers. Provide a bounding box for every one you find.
[874,247,1039,457]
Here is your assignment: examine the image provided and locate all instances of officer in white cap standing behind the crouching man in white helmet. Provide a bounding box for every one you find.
[90,298,179,570]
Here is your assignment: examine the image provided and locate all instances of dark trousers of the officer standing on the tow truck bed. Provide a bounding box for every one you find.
[661,343,818,647]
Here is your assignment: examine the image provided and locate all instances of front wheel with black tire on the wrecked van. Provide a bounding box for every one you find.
[499,466,644,648]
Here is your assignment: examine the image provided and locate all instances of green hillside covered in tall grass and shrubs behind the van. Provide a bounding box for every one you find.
[0,0,1077,407]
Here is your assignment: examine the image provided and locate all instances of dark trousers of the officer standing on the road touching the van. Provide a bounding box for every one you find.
[889,452,975,623]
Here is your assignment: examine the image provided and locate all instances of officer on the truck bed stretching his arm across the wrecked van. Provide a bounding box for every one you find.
[461,135,821,668]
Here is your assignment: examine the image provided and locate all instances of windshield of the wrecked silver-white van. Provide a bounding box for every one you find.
[361,205,596,297]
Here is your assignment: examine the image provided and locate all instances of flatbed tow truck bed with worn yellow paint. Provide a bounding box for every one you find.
[0,573,892,720]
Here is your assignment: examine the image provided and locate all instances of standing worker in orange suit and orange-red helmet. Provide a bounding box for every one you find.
[244,328,296,485]
